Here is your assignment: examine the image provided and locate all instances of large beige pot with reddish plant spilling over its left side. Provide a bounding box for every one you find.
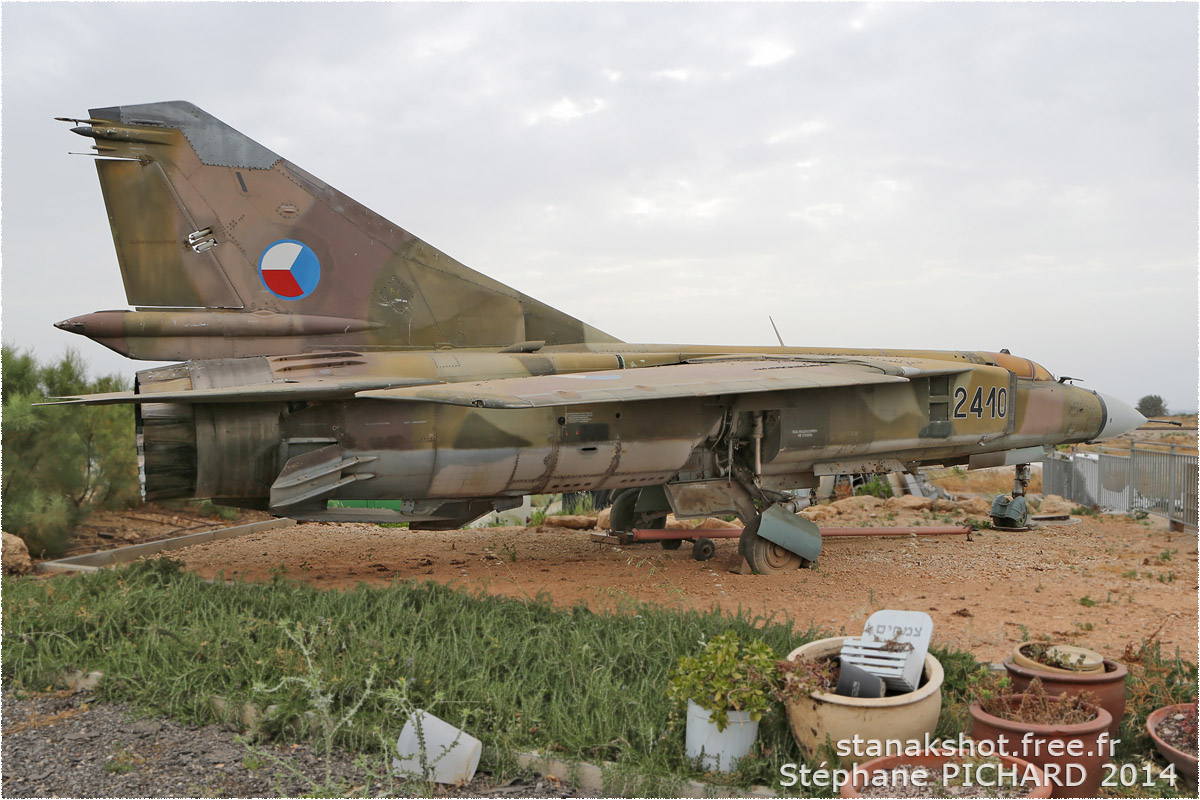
[779,636,944,765]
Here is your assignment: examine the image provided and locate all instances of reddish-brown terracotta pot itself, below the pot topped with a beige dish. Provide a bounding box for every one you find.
[971,694,1112,798]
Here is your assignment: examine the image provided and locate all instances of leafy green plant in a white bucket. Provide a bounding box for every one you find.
[667,631,775,772]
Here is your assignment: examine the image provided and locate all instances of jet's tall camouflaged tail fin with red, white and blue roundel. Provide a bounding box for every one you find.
[59,102,618,360]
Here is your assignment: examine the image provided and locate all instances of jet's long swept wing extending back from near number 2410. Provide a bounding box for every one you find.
[356,360,908,408]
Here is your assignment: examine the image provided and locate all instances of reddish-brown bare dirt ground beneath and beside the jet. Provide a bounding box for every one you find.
[172,512,1198,661]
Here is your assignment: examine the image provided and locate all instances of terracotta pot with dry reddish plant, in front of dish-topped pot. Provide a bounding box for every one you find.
[970,678,1112,798]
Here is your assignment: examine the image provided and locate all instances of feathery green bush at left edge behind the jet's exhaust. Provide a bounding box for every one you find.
[0,347,139,554]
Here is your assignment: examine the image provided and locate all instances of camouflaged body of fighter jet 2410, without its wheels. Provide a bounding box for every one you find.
[59,102,1139,566]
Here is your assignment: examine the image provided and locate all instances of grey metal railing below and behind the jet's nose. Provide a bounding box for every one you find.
[1042,441,1200,528]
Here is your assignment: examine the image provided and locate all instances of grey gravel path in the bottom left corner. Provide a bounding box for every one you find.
[0,692,574,798]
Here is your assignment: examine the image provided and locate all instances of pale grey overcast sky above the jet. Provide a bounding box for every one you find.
[0,2,1198,409]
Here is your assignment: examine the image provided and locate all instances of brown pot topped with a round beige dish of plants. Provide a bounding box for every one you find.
[1004,642,1129,738]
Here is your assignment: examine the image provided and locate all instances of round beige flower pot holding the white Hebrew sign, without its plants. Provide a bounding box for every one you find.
[786,636,944,766]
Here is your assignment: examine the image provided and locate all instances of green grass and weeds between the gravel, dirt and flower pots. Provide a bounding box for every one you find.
[2,559,1195,795]
